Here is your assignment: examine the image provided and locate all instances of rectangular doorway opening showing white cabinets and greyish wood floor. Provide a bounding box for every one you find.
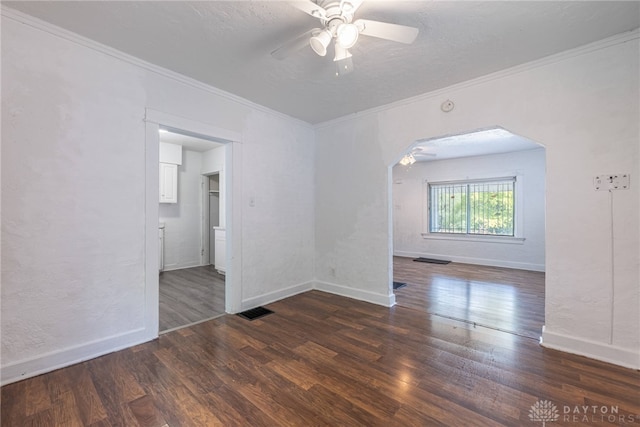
[158,127,225,332]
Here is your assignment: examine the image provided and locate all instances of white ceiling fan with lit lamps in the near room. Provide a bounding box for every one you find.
[271,0,418,74]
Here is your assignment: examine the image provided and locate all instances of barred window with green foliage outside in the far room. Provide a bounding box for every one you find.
[428,177,516,236]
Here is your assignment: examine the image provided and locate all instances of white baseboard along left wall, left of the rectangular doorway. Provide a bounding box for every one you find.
[0,328,158,386]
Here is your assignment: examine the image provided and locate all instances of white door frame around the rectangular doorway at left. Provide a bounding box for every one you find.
[144,108,242,339]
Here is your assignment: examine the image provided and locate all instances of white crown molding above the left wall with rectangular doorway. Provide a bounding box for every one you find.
[0,5,313,129]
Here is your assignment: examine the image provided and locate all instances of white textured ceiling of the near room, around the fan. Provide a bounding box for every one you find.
[3,0,640,124]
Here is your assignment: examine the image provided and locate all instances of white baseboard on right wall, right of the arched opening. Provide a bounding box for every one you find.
[540,326,640,370]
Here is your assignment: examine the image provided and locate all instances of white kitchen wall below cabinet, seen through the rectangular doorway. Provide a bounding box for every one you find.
[159,149,203,271]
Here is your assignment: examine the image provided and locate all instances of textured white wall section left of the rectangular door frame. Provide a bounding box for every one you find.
[1,14,149,376]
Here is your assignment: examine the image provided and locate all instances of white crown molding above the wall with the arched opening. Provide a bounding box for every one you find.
[314,28,640,130]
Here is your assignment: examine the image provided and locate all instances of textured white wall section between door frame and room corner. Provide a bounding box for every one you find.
[242,111,315,306]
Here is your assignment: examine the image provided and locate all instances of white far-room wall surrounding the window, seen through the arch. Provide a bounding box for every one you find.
[392,148,545,271]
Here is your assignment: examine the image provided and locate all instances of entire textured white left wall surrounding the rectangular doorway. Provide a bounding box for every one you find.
[1,7,314,383]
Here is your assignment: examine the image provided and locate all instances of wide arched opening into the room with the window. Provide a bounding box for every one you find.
[390,127,545,339]
